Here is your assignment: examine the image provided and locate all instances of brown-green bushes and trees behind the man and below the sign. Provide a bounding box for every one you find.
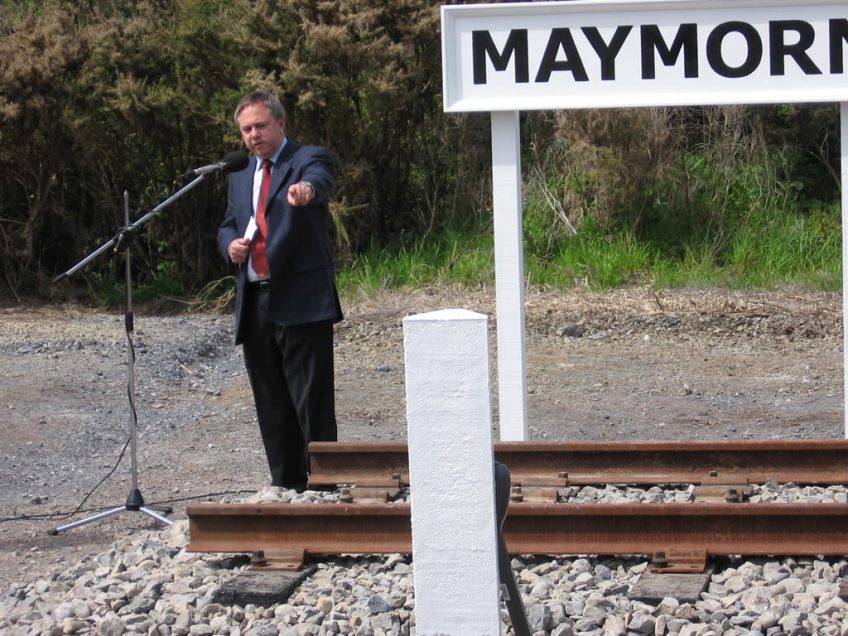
[0,0,838,298]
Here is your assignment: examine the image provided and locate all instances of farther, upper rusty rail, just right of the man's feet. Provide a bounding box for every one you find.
[309,439,848,486]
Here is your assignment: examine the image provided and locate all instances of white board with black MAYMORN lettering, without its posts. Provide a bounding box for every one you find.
[442,0,848,112]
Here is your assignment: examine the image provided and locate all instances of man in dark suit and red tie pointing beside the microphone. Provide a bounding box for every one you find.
[218,91,342,491]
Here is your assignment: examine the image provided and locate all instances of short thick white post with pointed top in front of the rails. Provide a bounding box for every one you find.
[403,309,501,636]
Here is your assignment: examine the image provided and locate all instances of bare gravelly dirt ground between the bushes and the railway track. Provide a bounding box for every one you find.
[0,288,845,591]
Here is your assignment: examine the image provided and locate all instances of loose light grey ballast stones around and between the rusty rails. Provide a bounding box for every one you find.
[0,487,848,636]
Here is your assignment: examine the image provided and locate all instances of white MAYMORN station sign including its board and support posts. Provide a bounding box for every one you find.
[442,0,848,440]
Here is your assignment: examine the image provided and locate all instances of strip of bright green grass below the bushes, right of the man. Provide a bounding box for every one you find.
[338,201,842,296]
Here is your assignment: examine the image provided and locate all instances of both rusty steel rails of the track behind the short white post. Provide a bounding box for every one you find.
[188,440,848,572]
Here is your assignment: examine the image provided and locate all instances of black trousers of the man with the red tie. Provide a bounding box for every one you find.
[242,286,337,489]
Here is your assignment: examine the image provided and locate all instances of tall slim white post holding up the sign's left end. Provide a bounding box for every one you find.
[492,111,527,441]
